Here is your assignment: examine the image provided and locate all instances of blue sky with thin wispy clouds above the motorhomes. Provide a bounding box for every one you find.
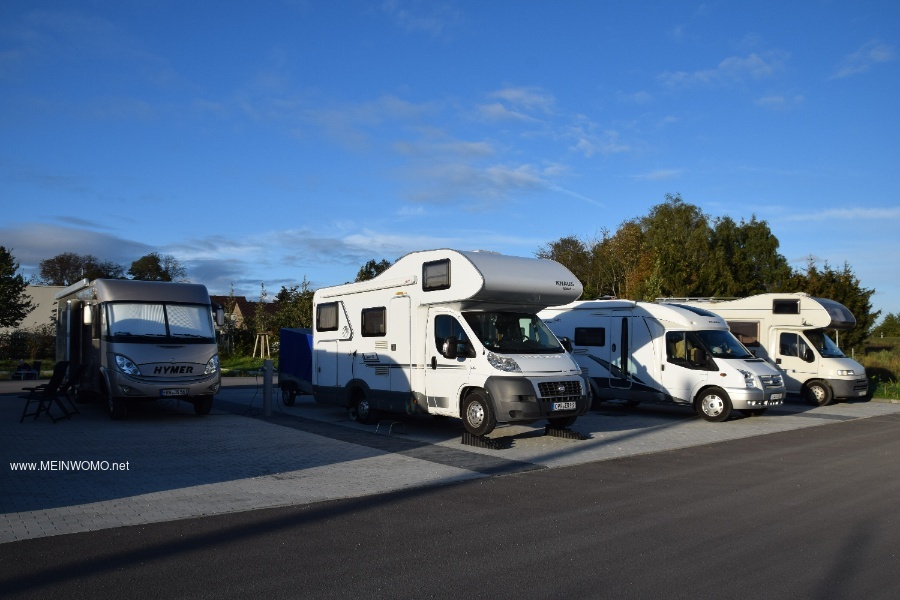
[0,0,900,322]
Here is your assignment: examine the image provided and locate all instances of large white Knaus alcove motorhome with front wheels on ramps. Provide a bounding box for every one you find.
[312,249,590,436]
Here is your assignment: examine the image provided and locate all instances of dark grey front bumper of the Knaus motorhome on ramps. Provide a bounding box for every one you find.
[485,375,591,423]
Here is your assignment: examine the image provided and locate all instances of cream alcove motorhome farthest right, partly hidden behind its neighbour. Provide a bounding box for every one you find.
[661,292,869,406]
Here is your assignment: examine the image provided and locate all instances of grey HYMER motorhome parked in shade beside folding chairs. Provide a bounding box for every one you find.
[56,279,222,419]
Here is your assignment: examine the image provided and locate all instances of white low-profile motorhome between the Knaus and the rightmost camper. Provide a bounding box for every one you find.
[538,300,785,422]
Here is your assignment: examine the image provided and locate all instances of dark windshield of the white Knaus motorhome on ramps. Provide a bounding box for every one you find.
[463,312,565,354]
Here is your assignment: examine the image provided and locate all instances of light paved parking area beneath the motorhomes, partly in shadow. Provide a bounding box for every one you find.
[0,378,900,543]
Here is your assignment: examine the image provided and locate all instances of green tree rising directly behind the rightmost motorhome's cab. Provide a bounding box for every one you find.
[779,257,881,352]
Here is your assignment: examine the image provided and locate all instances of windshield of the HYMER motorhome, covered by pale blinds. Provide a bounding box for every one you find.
[104,302,215,342]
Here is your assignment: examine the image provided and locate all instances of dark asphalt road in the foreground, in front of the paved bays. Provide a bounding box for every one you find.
[0,414,900,599]
